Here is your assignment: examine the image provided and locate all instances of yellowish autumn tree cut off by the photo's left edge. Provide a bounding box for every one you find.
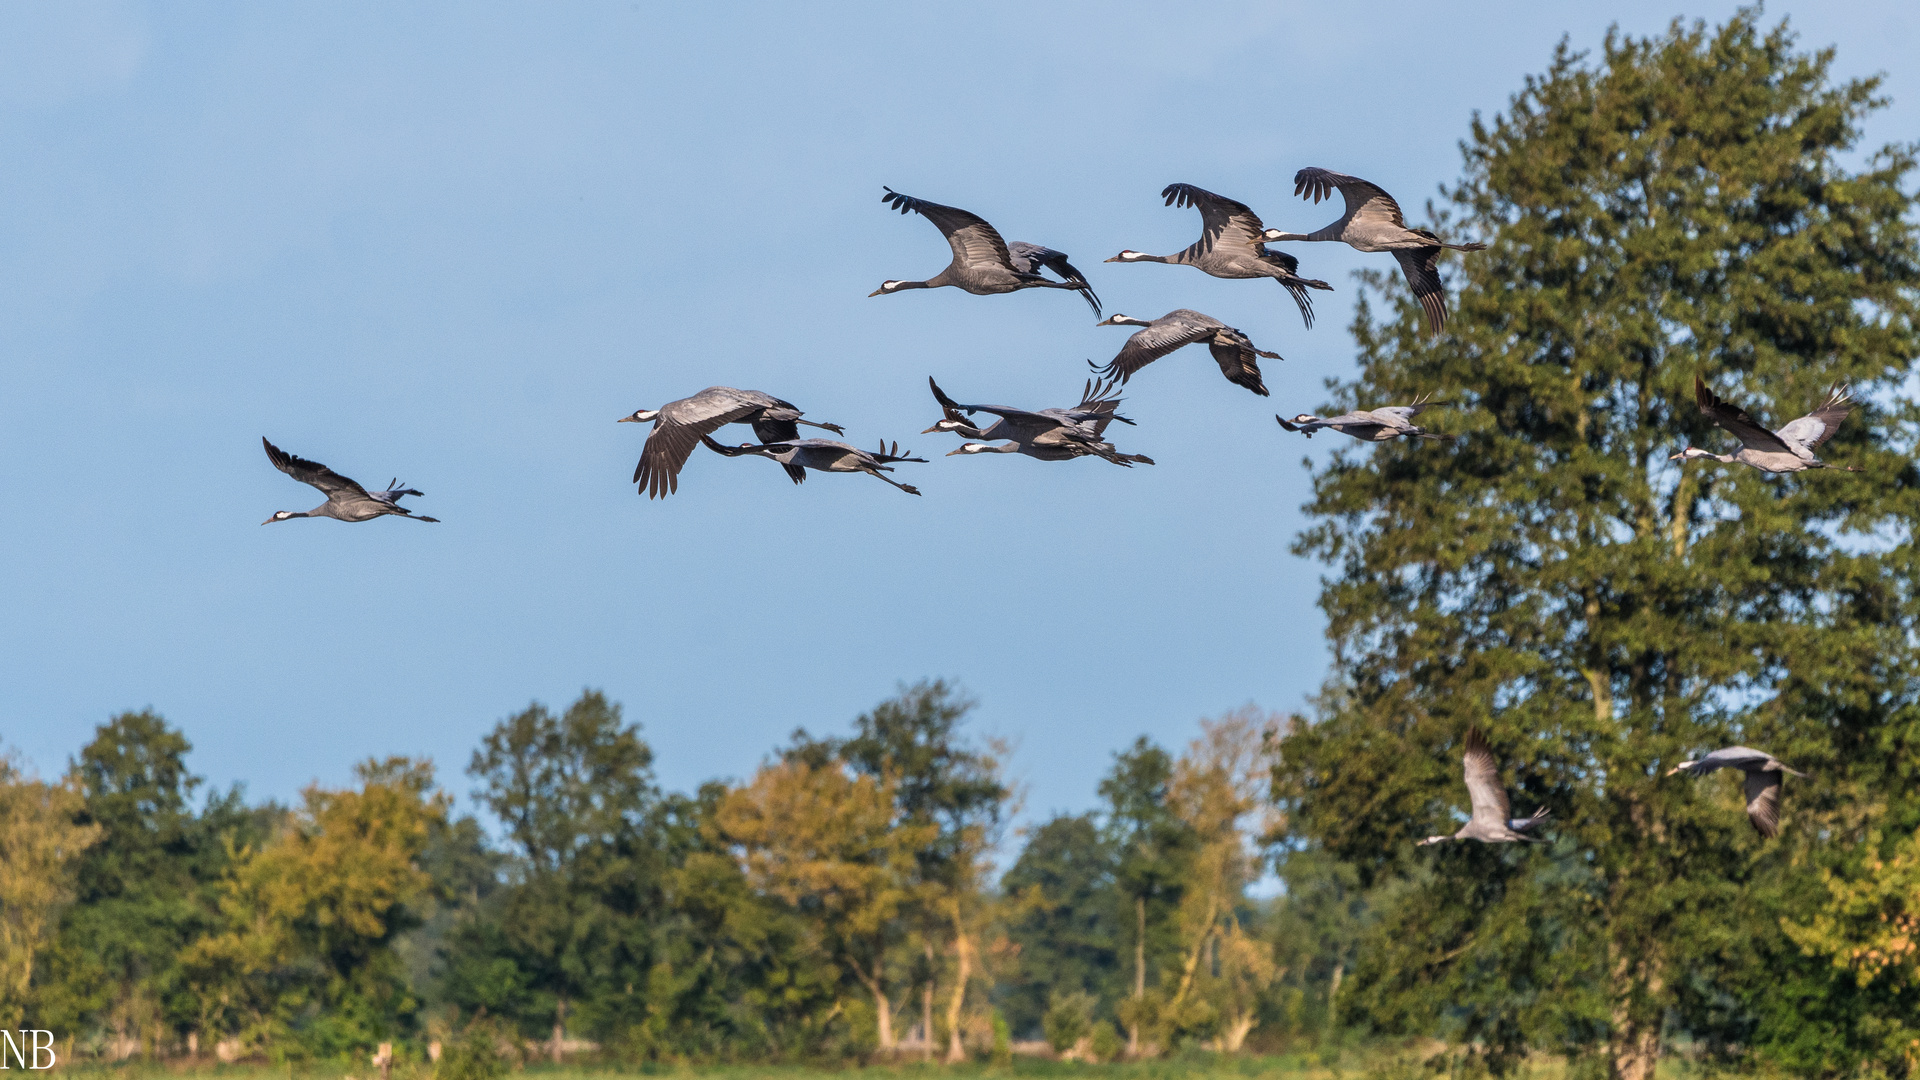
[0,755,100,1028]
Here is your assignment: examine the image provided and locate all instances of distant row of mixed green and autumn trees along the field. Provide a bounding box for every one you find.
[0,682,1356,1061]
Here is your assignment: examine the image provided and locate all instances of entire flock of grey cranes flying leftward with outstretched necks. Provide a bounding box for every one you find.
[261,169,1859,846]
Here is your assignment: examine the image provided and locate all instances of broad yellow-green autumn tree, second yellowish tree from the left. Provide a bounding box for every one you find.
[186,757,447,1057]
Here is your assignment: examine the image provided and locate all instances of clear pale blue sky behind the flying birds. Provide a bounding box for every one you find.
[0,2,1920,815]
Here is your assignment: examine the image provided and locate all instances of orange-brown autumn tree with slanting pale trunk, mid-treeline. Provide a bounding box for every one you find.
[712,757,937,1053]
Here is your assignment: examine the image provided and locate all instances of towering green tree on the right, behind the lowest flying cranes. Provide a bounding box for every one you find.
[1275,10,1920,1080]
